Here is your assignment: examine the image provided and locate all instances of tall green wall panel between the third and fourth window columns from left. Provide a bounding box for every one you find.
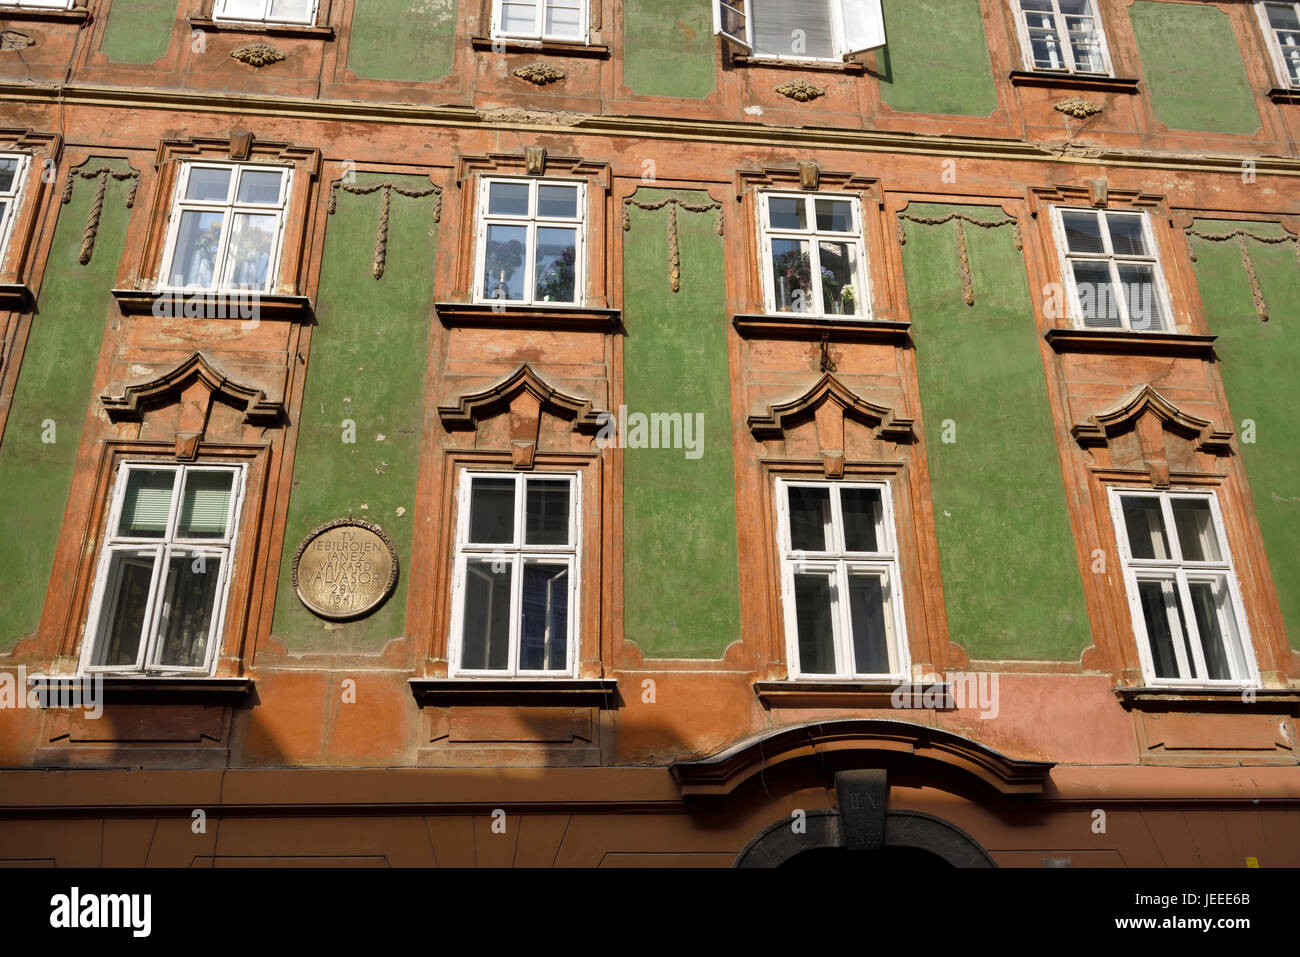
[904,205,1091,661]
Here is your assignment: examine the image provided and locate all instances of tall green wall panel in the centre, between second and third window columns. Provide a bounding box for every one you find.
[623,189,740,658]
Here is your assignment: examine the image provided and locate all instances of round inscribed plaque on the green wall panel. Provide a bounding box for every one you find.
[293,519,398,620]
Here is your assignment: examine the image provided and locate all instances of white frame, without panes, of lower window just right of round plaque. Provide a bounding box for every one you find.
[447,468,582,680]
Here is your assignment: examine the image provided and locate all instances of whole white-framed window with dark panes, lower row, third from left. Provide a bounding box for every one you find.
[776,479,910,680]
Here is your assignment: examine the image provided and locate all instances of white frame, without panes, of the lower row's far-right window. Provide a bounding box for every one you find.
[1109,485,1260,689]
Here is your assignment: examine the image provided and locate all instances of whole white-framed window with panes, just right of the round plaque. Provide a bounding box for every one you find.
[450,469,582,677]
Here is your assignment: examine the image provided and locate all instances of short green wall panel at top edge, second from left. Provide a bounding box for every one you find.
[347,0,456,83]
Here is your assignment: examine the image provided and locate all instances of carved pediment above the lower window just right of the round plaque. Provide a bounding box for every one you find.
[438,364,608,468]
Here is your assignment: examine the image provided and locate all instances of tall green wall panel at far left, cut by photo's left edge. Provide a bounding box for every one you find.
[0,157,131,651]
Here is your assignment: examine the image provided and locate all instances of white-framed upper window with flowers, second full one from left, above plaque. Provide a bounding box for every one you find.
[475,178,586,306]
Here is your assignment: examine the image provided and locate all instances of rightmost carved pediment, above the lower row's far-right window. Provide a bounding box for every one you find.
[1070,385,1232,485]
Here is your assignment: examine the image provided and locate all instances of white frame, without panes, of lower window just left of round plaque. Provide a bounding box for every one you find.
[78,459,248,676]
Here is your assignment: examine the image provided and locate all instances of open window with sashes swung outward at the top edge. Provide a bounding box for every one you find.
[714,0,885,60]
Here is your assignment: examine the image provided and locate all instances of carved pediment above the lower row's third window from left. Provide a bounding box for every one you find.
[748,372,917,479]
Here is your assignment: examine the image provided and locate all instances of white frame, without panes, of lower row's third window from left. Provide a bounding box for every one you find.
[776,477,911,681]
